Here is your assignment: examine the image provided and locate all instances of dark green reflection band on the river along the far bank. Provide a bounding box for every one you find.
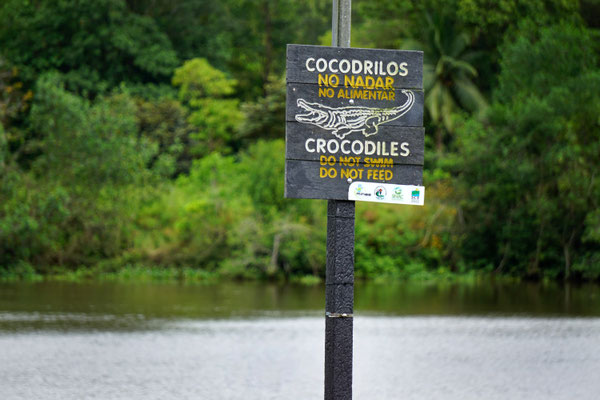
[0,282,600,331]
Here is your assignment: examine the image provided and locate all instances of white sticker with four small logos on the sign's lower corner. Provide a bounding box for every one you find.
[348,182,425,206]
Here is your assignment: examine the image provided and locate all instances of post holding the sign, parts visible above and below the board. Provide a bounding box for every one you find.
[325,0,354,400]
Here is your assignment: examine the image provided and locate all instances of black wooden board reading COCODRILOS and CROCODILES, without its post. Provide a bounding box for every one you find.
[285,45,425,204]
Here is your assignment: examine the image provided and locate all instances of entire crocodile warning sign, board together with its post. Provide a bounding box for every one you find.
[285,0,425,400]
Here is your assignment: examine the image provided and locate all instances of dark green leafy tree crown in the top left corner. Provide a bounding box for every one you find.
[0,0,178,95]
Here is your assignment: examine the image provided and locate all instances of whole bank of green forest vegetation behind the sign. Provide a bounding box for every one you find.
[0,0,600,283]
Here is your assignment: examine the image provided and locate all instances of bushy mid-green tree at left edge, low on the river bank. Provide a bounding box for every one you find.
[5,74,156,266]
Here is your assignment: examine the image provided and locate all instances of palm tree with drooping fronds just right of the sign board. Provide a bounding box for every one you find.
[403,12,487,152]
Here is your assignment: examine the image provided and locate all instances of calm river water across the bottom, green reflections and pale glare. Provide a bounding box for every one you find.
[0,282,600,400]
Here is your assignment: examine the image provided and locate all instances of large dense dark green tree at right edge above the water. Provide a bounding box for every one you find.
[455,23,600,278]
